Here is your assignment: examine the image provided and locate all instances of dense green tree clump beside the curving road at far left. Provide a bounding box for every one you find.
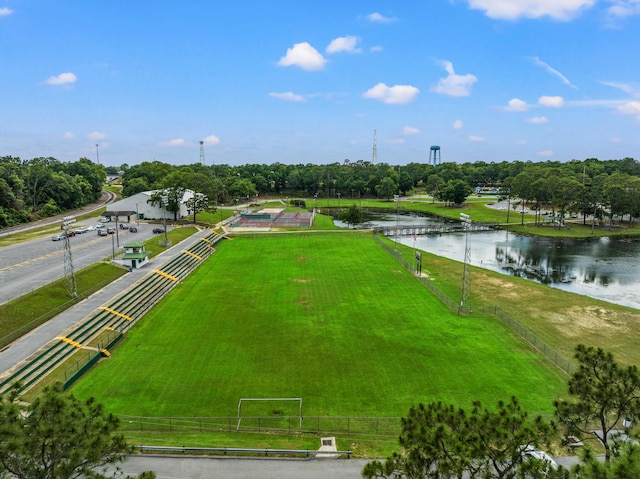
[0,156,106,228]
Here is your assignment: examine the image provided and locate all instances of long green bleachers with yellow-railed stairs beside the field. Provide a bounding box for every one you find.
[0,232,224,395]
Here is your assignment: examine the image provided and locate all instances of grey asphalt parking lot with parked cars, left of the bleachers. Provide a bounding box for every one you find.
[0,216,169,304]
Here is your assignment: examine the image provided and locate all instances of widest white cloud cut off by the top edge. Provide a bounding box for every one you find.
[467,0,595,20]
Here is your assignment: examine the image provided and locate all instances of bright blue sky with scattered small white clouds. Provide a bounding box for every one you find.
[0,0,640,165]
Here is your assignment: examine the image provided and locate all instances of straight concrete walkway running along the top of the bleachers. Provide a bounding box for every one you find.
[0,229,211,375]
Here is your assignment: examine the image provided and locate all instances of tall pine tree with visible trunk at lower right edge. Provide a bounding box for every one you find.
[554,344,640,461]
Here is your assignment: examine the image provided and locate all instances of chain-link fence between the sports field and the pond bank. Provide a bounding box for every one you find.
[373,235,575,375]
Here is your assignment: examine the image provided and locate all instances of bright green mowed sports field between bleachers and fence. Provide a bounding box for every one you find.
[73,233,566,417]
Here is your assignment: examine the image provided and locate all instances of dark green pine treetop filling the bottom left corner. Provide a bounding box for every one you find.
[0,383,155,479]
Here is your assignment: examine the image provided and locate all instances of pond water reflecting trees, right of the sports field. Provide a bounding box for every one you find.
[336,214,640,309]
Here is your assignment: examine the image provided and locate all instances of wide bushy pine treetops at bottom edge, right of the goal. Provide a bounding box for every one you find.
[362,398,565,479]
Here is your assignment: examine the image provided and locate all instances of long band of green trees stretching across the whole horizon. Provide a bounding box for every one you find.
[0,157,640,227]
